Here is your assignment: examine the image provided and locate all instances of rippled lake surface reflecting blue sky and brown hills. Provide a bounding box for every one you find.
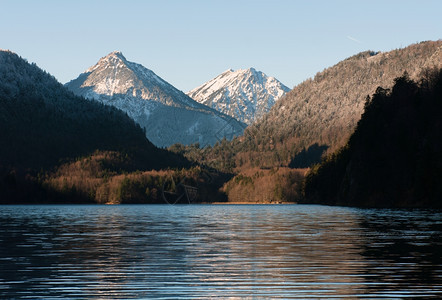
[0,205,442,299]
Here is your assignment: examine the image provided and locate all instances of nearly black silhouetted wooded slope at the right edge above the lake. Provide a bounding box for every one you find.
[305,69,442,207]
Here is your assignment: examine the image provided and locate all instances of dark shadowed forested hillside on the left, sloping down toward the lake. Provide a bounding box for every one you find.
[0,51,188,202]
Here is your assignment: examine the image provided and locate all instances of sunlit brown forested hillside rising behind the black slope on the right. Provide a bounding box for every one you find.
[238,41,442,166]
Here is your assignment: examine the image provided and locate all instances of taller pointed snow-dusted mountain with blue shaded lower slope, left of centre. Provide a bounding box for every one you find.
[66,51,245,147]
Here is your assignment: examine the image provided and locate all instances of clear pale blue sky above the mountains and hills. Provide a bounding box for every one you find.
[0,0,442,91]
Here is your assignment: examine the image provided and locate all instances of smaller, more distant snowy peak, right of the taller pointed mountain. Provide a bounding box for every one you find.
[187,68,290,124]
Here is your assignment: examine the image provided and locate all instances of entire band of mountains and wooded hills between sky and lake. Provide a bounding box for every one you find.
[0,40,442,207]
